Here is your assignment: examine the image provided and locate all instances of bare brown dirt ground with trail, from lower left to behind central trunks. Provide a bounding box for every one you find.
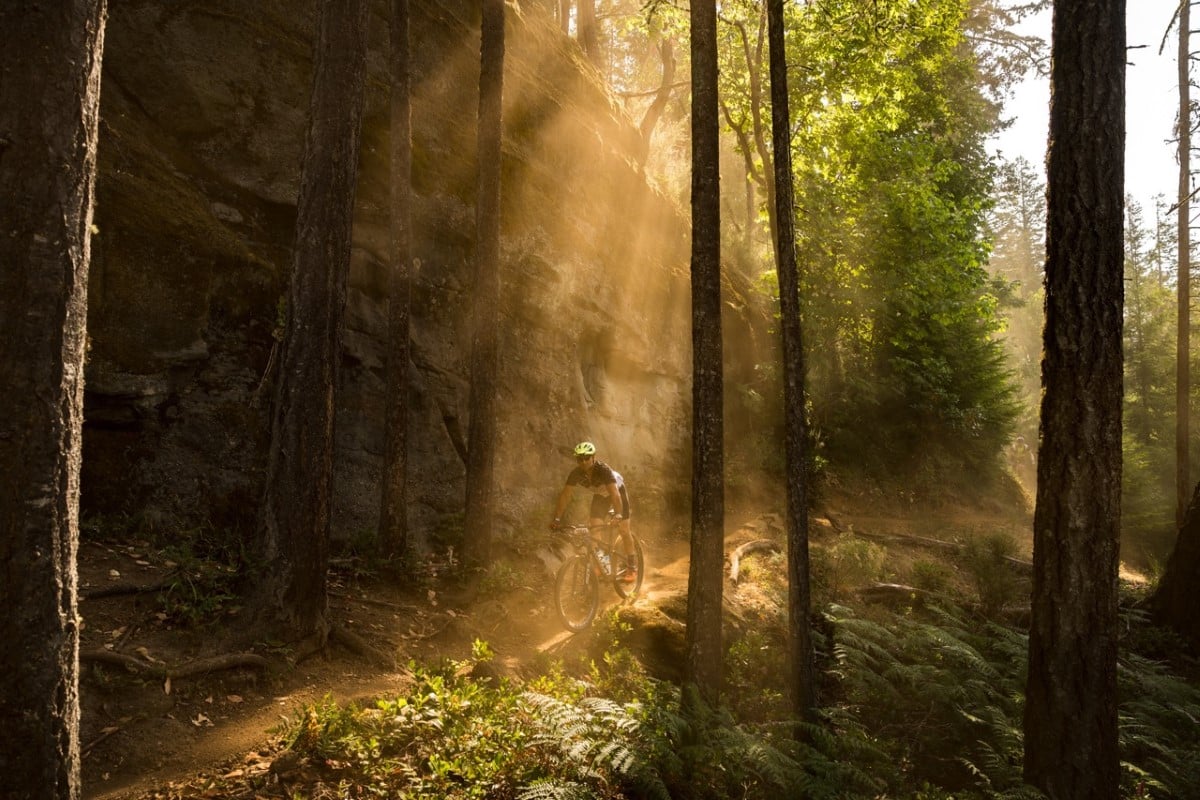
[78,498,1051,800]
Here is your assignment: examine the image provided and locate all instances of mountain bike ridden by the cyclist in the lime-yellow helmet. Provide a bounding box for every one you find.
[554,519,646,632]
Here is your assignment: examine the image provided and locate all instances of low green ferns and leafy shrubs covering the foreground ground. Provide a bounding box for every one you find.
[150,606,1200,800]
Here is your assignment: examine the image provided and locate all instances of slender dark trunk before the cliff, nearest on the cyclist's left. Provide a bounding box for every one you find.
[463,0,504,569]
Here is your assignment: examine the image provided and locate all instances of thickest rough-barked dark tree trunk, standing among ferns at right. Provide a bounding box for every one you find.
[1025,0,1126,800]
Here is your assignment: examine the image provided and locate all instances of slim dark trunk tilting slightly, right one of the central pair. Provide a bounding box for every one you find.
[767,0,816,722]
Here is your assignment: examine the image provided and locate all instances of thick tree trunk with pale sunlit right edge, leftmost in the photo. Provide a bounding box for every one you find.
[0,0,106,800]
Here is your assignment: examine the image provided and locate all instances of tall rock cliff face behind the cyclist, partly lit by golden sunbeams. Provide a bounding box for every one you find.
[83,0,690,539]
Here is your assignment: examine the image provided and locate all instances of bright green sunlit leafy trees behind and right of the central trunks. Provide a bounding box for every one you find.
[720,0,1020,497]
